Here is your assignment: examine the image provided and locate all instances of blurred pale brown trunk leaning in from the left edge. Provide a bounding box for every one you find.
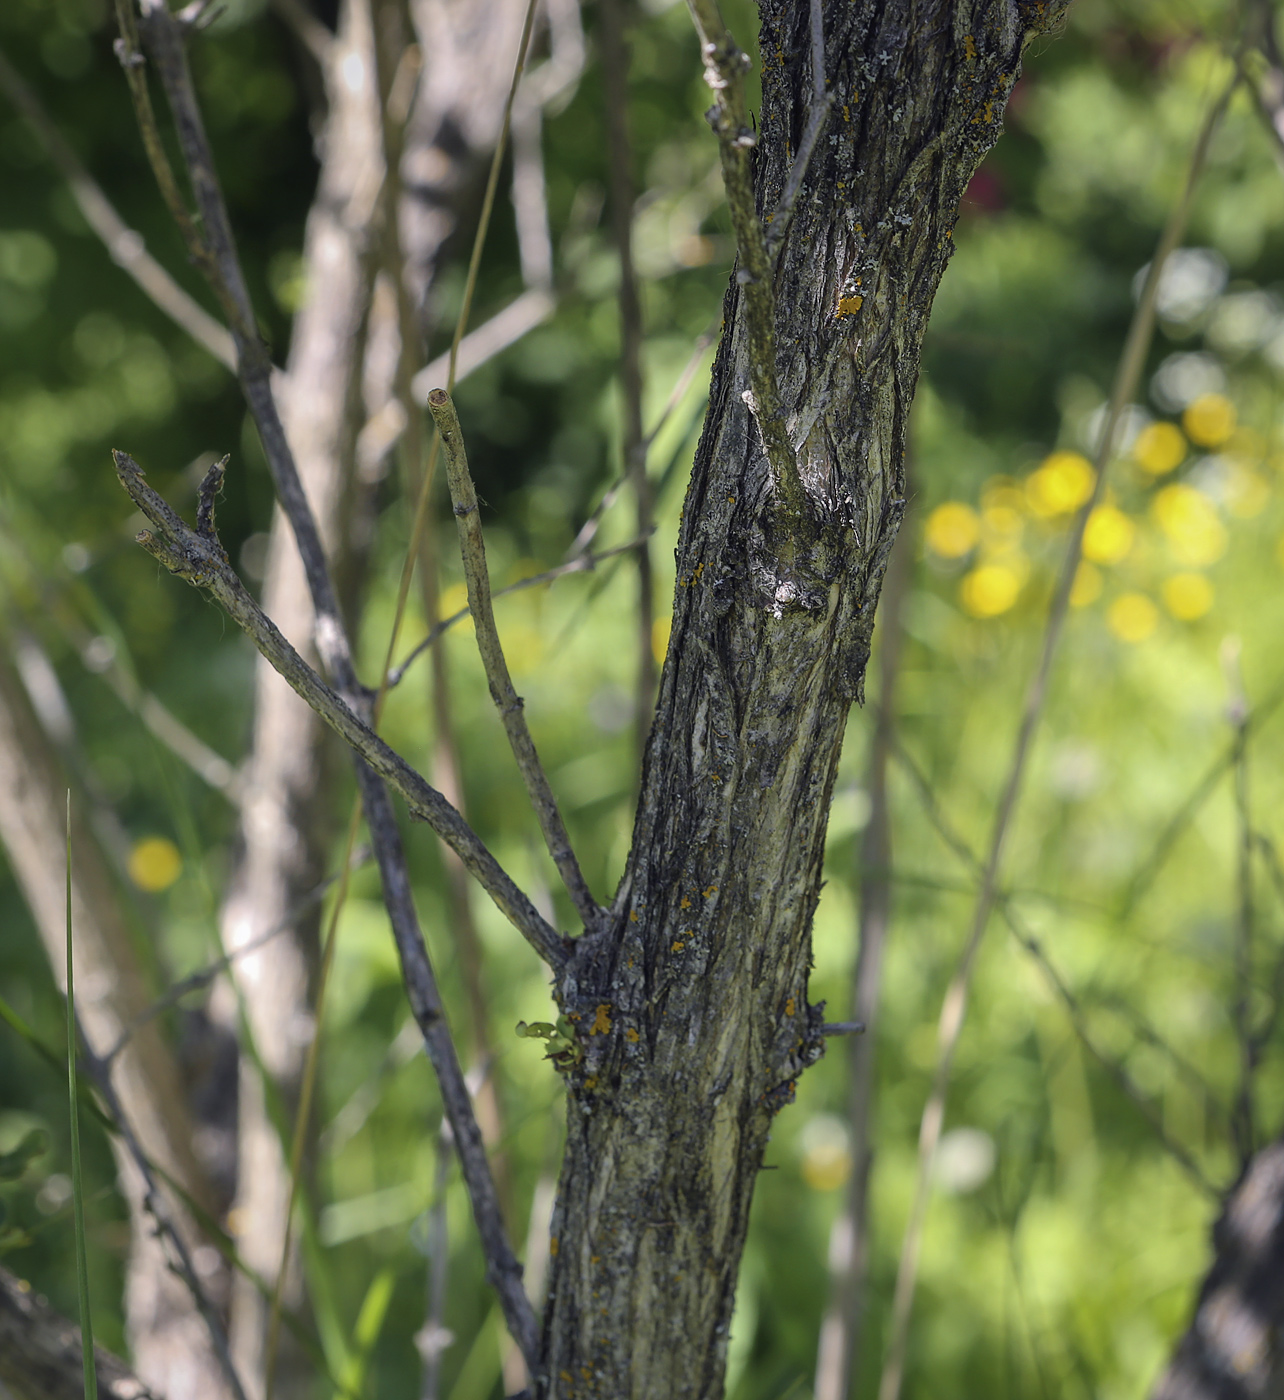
[0,651,225,1400]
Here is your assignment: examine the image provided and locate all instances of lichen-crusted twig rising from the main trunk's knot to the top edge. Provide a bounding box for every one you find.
[688,0,807,518]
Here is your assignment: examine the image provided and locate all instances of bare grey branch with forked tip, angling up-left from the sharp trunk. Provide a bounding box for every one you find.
[115,452,567,972]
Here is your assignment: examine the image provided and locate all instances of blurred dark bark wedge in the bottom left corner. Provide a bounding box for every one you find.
[0,1267,160,1400]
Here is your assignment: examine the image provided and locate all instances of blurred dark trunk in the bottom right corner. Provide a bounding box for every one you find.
[1151,1138,1284,1400]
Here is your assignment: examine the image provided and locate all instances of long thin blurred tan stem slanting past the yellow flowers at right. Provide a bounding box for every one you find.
[878,63,1241,1400]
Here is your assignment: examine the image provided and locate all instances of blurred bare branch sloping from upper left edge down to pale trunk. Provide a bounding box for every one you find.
[0,53,237,370]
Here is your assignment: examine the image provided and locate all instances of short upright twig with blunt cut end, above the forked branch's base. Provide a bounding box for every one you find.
[428,389,602,931]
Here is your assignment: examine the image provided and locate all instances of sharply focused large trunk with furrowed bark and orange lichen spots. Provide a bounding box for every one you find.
[540,0,1066,1400]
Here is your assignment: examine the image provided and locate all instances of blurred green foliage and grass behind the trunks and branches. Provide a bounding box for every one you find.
[0,0,1284,1400]
